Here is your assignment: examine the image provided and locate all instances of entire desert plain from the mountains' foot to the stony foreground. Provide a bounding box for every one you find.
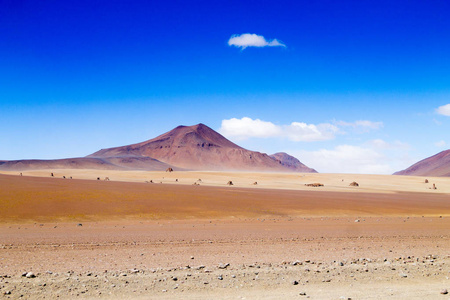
[0,169,450,299]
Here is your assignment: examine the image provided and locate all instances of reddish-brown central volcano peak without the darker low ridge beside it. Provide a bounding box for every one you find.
[88,124,314,172]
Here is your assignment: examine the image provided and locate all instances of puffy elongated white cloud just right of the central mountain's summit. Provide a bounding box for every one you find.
[219,117,339,142]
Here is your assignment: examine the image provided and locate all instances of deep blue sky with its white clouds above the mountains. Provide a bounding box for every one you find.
[0,0,450,174]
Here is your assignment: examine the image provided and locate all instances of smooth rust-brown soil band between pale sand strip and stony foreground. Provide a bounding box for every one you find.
[0,175,450,222]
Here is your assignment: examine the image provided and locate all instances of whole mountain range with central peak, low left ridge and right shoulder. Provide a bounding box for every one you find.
[0,124,316,172]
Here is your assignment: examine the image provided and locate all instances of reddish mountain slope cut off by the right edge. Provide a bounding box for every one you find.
[394,150,450,176]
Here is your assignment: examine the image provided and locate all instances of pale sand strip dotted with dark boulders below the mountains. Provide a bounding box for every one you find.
[0,169,450,194]
